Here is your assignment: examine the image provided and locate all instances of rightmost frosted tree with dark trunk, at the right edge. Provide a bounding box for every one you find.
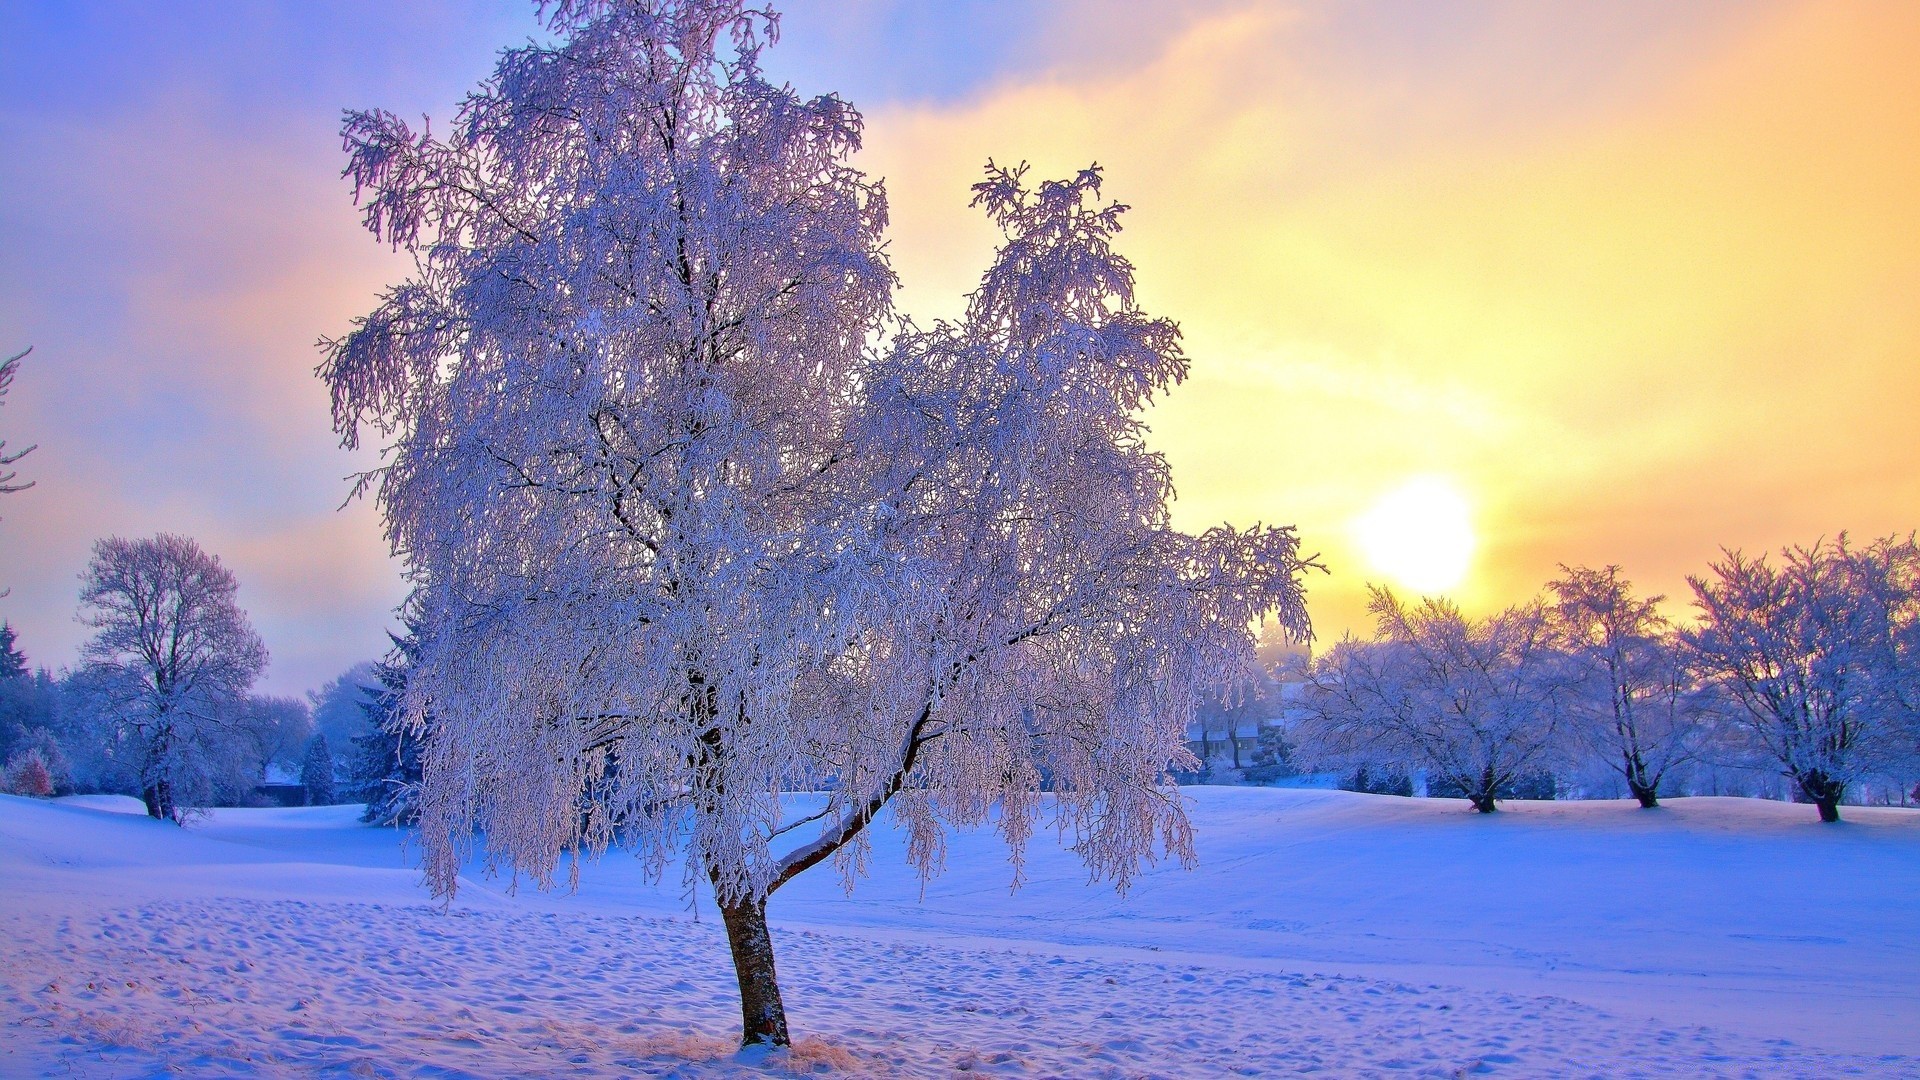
[1684,532,1920,822]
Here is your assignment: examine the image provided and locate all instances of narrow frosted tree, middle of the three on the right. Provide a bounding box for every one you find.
[1546,565,1716,809]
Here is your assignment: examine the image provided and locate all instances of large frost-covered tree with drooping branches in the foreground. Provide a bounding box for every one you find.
[321,0,1308,1043]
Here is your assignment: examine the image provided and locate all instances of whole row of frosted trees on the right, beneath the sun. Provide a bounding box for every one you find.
[1290,534,1920,821]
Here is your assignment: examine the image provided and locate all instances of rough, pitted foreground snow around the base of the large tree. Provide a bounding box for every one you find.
[6,901,1889,1078]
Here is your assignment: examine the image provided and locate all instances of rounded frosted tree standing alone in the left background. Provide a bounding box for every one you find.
[75,532,267,821]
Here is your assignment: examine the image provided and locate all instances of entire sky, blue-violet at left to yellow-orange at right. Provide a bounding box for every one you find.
[0,0,1920,694]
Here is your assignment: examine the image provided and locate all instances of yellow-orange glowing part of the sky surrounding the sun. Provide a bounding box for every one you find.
[864,2,1920,640]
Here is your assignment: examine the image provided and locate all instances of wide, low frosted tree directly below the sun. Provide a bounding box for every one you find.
[1294,588,1561,813]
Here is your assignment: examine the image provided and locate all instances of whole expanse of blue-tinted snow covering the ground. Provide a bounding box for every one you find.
[0,788,1920,1078]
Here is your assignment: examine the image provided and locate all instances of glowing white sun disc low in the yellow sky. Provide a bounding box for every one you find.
[1354,477,1475,596]
